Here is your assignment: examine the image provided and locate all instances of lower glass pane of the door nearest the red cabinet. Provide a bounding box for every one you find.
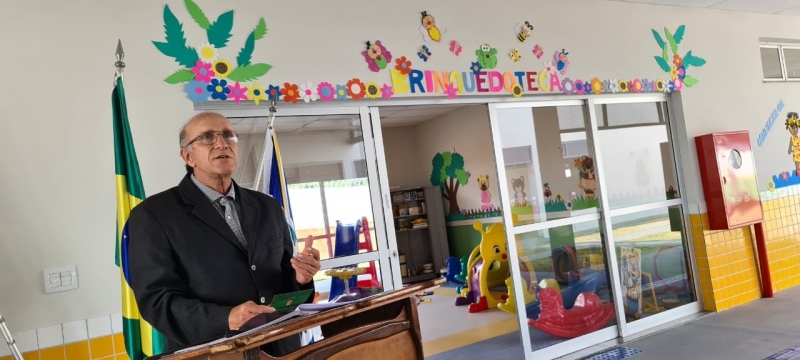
[611,206,697,322]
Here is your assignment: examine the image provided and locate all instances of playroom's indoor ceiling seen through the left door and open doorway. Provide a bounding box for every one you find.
[231,105,468,134]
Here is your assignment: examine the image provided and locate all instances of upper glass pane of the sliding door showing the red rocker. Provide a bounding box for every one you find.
[497,106,598,226]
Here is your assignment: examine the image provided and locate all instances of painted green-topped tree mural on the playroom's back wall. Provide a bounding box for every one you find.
[431,151,470,214]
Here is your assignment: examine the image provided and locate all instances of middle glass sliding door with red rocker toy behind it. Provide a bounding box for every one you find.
[489,100,618,358]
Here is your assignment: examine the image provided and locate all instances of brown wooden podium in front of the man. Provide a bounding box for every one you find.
[149,279,445,360]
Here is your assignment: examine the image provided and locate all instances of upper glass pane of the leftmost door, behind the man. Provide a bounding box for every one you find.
[231,115,377,260]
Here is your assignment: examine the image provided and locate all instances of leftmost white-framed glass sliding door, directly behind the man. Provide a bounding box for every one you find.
[230,108,395,301]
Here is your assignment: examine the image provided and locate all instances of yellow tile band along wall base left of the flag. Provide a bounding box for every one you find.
[0,333,130,360]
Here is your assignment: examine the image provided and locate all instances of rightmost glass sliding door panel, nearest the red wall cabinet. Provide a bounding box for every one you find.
[591,97,699,336]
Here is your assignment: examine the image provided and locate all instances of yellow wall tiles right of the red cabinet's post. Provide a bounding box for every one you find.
[763,194,800,292]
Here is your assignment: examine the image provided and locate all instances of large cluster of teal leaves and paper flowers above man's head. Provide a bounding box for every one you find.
[153,0,277,103]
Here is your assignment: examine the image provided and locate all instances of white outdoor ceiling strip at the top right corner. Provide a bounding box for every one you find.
[610,0,800,15]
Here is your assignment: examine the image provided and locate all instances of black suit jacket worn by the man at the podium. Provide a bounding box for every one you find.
[127,175,314,355]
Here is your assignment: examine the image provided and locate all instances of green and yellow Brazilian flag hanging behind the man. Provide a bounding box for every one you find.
[111,76,165,360]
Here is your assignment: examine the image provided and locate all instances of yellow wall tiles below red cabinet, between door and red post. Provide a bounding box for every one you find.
[689,214,761,311]
